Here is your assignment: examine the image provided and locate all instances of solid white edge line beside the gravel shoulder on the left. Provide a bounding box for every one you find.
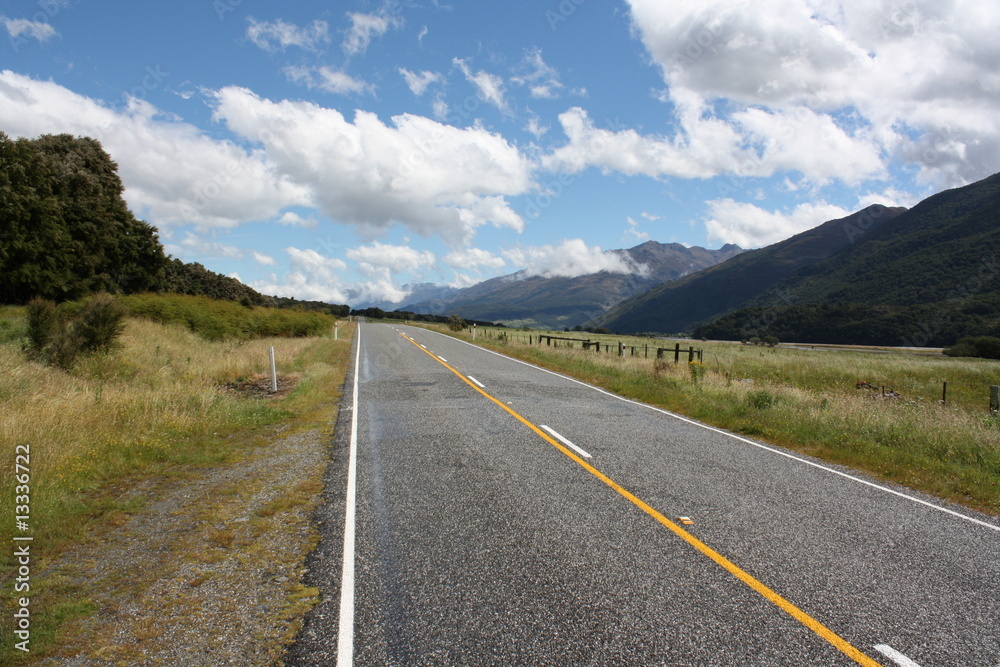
[337,324,361,667]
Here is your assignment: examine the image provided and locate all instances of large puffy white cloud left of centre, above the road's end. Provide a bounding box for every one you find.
[215,87,533,245]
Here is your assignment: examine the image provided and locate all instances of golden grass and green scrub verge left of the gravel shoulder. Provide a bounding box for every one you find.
[0,295,353,664]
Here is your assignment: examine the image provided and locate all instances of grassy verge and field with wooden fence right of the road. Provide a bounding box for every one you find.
[428,327,1000,515]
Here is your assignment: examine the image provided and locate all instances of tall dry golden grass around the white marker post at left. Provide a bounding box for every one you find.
[0,316,342,556]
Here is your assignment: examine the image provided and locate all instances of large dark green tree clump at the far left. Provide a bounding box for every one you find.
[0,132,165,303]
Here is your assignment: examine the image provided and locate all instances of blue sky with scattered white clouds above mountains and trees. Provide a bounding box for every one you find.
[0,0,1000,305]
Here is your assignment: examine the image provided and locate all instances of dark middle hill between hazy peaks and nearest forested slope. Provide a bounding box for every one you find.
[592,206,906,334]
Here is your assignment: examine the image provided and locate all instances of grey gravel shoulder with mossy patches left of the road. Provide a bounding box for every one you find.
[38,425,332,667]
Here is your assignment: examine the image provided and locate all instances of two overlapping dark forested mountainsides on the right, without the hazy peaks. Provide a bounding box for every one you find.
[595,174,1000,346]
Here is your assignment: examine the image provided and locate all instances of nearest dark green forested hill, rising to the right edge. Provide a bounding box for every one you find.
[695,174,1000,346]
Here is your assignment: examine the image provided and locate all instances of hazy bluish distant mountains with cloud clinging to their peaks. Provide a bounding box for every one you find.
[401,241,743,329]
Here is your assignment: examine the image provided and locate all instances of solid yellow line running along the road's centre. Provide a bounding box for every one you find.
[400,334,881,667]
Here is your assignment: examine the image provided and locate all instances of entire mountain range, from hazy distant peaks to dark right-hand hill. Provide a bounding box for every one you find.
[376,174,1000,346]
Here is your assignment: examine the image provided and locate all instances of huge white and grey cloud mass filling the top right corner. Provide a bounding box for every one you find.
[629,0,1000,185]
